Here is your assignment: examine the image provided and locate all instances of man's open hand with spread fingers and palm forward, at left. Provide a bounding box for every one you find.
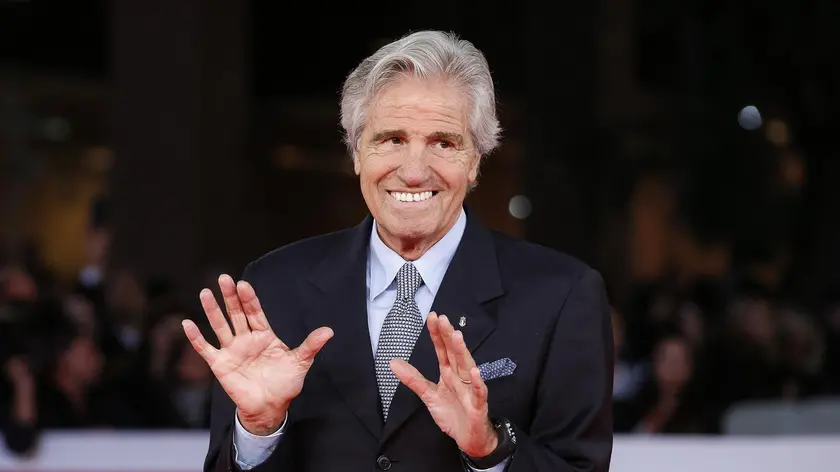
[183,275,333,436]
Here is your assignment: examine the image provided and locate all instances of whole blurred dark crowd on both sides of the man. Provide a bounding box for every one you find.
[0,201,840,454]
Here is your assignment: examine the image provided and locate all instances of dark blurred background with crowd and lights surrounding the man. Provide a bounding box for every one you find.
[0,0,840,470]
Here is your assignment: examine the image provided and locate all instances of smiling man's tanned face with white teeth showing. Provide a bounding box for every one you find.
[354,78,479,257]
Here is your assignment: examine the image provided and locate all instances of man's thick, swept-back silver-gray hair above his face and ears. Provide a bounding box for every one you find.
[341,31,501,156]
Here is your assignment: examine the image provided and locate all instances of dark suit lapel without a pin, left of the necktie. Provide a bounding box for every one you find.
[304,217,382,438]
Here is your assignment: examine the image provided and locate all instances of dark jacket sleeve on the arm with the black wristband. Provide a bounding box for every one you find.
[507,269,613,472]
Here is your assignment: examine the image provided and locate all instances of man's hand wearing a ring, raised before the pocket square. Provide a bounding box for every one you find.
[391,312,498,457]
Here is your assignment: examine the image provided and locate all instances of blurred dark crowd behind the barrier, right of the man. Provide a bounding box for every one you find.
[613,280,840,434]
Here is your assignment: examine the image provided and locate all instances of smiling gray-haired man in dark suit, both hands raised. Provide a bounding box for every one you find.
[184,32,612,472]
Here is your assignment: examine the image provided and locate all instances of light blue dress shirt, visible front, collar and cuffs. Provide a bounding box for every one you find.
[233,209,508,472]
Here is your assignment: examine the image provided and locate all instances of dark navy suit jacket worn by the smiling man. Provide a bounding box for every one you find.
[205,211,613,472]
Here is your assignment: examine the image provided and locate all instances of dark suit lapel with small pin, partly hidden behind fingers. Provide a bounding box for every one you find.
[381,208,504,443]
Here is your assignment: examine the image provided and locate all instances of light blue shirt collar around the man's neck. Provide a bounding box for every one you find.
[368,208,467,300]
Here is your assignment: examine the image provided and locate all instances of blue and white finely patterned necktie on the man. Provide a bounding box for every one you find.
[376,262,423,420]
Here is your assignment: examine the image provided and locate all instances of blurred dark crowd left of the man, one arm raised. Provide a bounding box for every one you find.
[0,215,217,454]
